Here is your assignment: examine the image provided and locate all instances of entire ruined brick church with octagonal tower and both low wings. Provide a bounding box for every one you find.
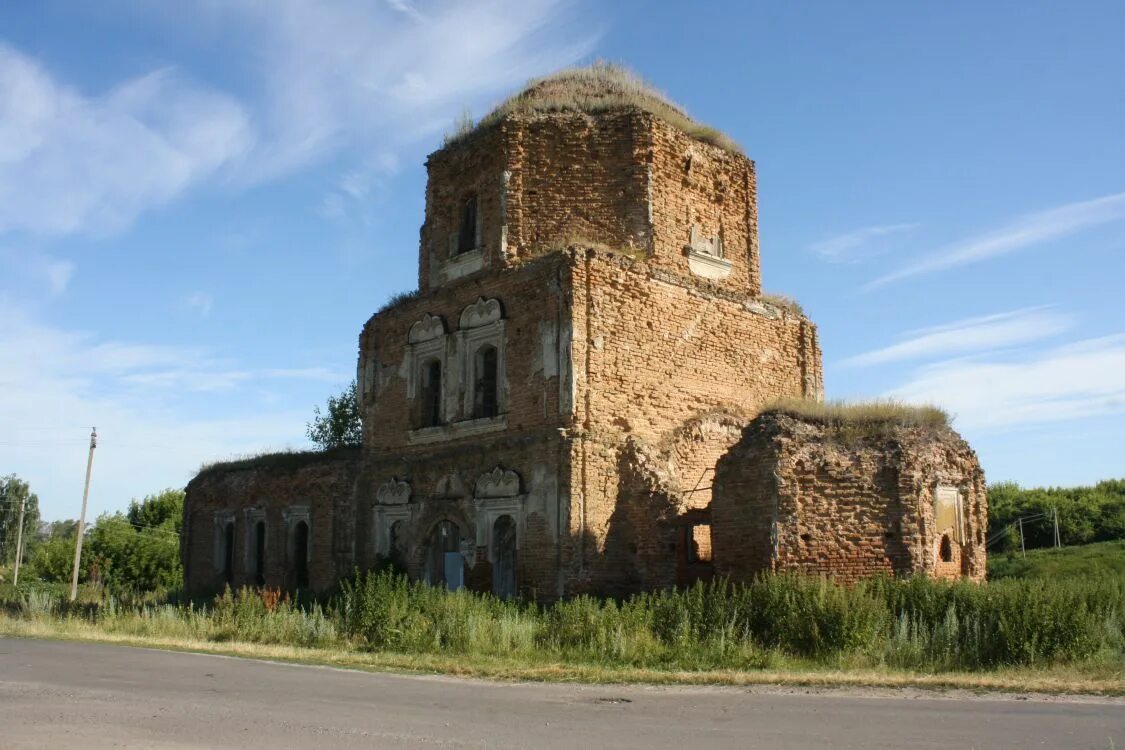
[181,66,987,600]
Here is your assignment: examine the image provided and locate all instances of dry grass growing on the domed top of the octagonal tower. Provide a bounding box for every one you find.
[446,61,741,153]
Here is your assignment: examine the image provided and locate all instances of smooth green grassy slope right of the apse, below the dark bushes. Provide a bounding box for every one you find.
[988,540,1125,580]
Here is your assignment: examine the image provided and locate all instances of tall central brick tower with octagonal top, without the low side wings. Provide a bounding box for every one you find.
[355,66,821,598]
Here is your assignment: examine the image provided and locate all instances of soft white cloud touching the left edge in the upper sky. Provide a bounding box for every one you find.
[0,44,251,236]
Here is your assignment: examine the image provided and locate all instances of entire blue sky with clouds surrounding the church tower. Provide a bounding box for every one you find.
[0,0,1125,518]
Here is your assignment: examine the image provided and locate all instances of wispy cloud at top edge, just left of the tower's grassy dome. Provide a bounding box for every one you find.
[209,0,597,182]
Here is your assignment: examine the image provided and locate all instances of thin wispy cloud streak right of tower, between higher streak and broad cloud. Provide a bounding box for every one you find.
[839,307,1073,367]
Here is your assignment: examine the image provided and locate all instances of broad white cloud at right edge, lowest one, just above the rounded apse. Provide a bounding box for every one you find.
[888,334,1125,430]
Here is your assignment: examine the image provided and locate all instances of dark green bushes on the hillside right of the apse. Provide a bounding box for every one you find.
[988,479,1125,552]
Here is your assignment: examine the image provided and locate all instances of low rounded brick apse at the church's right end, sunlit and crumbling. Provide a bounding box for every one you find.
[711,414,988,581]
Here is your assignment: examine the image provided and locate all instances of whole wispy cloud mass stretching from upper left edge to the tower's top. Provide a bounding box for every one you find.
[0,0,599,237]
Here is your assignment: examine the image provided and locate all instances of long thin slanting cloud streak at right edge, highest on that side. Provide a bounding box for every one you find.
[864,192,1125,290]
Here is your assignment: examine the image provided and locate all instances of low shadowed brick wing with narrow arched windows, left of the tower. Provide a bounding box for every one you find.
[180,451,359,594]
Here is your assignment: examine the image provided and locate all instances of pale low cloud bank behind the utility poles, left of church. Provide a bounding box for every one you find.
[0,299,350,517]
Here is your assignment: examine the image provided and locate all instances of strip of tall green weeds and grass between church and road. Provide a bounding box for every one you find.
[0,571,1125,680]
